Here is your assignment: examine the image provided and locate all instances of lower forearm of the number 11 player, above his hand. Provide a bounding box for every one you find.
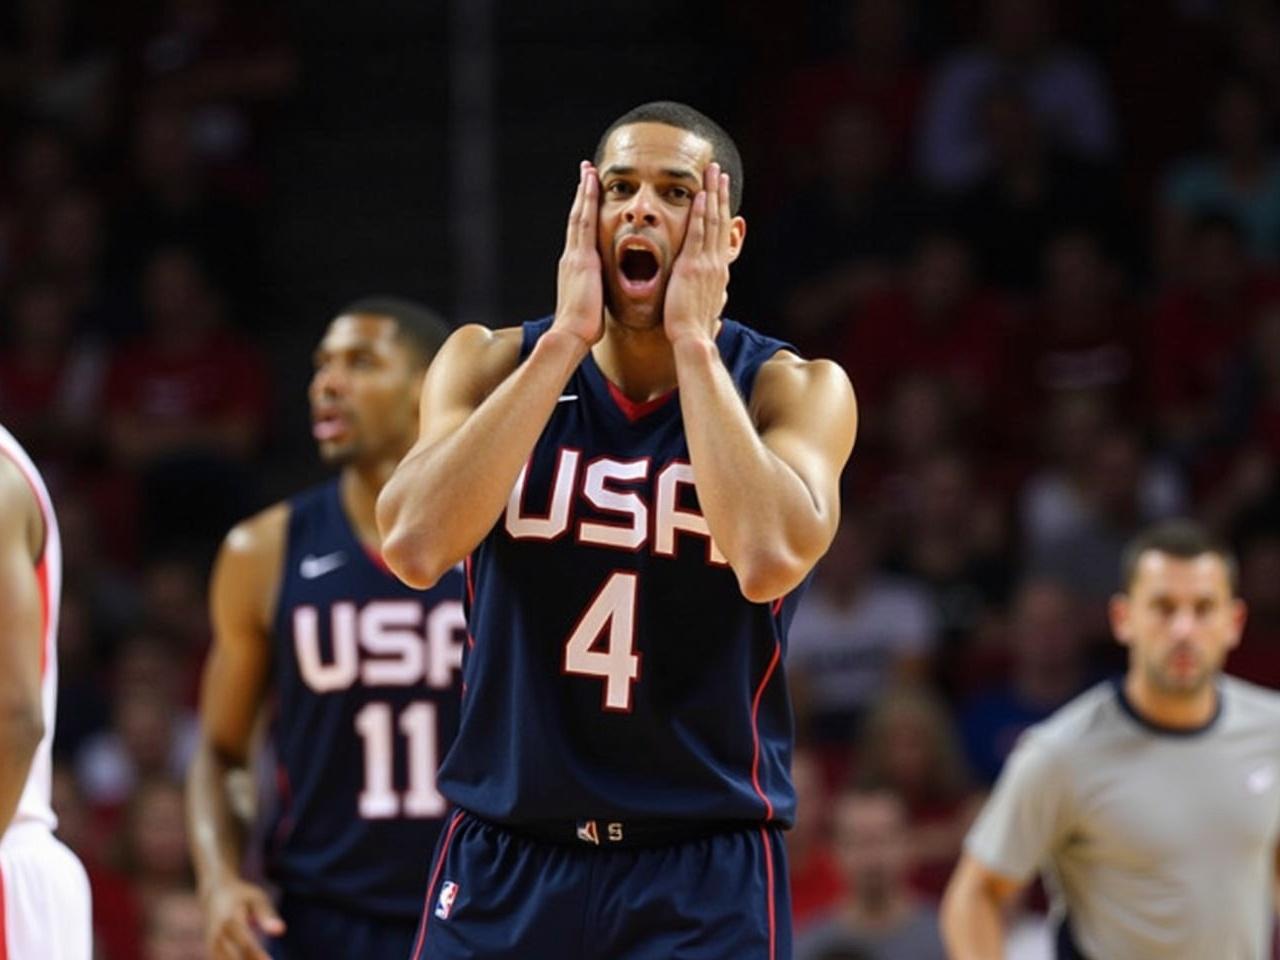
[187,740,247,893]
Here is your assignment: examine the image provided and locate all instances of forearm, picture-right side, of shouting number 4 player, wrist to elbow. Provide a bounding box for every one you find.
[675,339,829,602]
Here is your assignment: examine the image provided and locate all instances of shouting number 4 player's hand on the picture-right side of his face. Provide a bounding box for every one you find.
[662,163,733,343]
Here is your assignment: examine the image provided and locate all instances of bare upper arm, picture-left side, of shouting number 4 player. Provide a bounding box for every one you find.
[417,324,521,448]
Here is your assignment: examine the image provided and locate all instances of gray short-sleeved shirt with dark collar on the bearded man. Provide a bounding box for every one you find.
[965,677,1280,960]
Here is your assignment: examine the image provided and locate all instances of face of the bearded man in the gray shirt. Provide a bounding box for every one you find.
[1111,550,1244,696]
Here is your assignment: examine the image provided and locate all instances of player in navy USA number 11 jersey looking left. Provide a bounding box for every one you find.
[187,298,465,960]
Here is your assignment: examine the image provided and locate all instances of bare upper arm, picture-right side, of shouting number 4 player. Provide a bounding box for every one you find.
[751,355,858,541]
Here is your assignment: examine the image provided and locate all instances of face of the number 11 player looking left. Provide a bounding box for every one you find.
[307,314,422,466]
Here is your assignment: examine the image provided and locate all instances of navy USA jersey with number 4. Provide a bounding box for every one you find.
[440,319,800,824]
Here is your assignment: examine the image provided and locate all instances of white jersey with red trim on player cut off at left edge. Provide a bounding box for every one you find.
[0,426,63,829]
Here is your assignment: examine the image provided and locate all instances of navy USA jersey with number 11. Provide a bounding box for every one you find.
[268,481,466,918]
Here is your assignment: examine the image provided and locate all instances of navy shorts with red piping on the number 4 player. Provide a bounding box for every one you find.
[408,810,791,960]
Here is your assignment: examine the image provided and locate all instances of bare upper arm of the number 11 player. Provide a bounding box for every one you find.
[200,512,284,763]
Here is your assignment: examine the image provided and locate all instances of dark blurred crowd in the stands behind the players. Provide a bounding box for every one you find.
[0,0,1280,960]
